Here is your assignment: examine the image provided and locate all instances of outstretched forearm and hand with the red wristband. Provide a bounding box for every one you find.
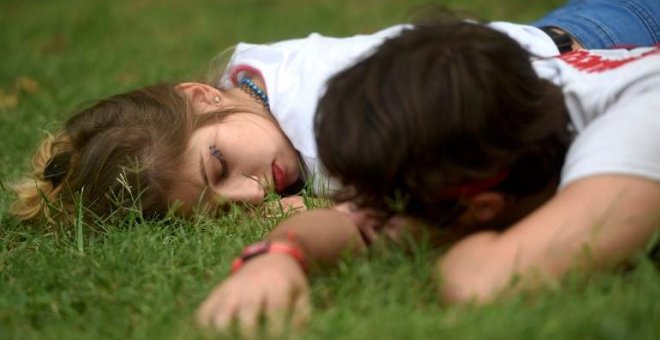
[197,208,364,334]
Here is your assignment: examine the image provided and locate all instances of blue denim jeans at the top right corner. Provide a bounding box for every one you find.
[532,0,660,49]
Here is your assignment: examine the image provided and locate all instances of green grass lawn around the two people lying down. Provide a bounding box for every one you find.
[0,0,660,339]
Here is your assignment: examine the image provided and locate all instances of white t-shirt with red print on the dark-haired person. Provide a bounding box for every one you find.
[532,47,660,186]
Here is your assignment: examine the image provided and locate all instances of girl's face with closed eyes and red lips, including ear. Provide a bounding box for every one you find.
[170,84,300,210]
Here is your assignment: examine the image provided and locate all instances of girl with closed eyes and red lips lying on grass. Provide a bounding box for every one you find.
[10,1,657,223]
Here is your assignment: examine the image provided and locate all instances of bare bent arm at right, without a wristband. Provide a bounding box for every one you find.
[438,175,660,303]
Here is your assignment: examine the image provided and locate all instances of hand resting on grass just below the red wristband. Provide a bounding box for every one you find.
[197,253,310,337]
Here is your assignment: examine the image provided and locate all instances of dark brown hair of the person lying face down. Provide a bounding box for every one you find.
[315,21,569,224]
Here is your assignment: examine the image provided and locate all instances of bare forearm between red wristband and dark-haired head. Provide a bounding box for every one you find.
[268,209,365,265]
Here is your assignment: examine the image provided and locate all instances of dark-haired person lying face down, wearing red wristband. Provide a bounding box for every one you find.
[198,14,660,329]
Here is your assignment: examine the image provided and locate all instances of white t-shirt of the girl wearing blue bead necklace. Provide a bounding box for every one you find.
[221,22,558,194]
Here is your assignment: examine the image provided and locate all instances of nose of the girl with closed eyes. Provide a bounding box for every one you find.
[213,176,266,204]
